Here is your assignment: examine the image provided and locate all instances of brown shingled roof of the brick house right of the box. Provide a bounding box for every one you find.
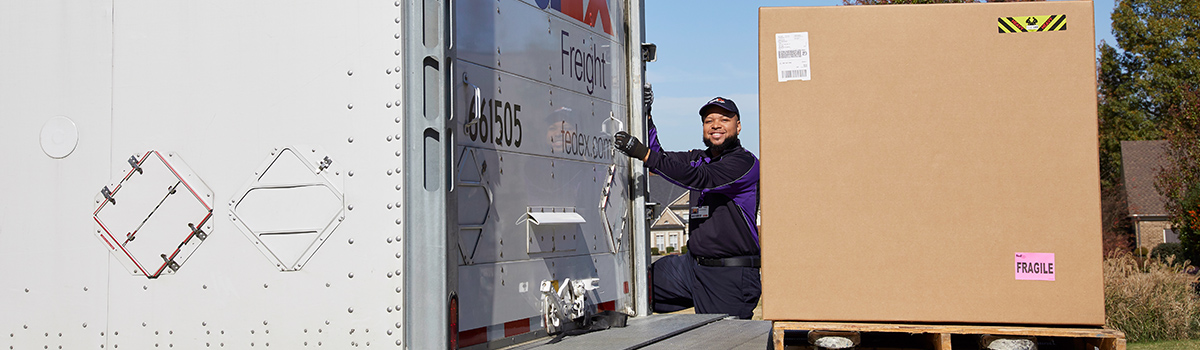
[1121,140,1166,216]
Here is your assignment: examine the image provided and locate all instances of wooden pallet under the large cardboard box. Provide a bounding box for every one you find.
[772,321,1126,350]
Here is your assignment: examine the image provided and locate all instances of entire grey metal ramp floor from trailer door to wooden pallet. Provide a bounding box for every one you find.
[504,314,770,350]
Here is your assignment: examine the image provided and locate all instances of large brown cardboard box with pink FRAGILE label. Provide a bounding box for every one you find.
[758,1,1104,325]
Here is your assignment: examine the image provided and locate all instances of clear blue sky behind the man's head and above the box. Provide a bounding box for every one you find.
[644,0,1116,155]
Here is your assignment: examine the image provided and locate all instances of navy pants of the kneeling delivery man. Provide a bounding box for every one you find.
[650,254,762,319]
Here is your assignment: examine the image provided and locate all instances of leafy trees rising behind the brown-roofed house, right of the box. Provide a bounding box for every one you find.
[1097,0,1200,261]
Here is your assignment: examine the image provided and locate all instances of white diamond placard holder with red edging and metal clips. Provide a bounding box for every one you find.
[92,150,212,278]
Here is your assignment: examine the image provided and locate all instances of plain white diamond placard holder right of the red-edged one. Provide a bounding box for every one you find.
[229,146,346,271]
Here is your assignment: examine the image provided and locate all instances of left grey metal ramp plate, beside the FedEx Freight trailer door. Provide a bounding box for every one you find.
[505,314,724,350]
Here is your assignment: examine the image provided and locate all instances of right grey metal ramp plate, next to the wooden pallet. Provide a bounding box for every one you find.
[642,320,770,350]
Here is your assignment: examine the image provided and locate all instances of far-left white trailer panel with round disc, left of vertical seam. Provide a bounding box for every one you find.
[0,1,113,349]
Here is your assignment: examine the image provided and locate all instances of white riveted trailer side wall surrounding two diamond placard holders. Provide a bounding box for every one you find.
[0,1,422,349]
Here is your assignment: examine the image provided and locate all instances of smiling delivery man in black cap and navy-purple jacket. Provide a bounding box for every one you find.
[614,93,762,319]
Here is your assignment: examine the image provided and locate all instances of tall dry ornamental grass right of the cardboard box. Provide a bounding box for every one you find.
[1104,254,1200,342]
